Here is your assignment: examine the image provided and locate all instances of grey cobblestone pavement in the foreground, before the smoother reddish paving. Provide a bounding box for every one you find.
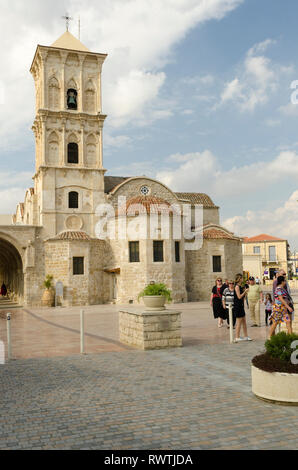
[0,340,298,450]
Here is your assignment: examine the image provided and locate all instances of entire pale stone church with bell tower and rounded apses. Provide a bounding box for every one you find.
[0,32,242,306]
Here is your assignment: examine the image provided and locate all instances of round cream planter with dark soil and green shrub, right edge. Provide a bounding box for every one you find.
[251,331,298,405]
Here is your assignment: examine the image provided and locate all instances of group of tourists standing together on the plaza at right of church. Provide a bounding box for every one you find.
[210,269,294,343]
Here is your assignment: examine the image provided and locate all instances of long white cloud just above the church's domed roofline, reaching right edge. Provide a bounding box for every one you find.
[156,150,298,196]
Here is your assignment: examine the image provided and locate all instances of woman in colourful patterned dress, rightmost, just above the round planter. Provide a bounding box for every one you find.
[269,276,293,338]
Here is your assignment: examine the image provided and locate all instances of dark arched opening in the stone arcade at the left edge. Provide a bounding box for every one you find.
[0,237,24,302]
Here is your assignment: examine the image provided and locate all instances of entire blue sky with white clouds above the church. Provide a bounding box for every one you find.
[0,0,298,250]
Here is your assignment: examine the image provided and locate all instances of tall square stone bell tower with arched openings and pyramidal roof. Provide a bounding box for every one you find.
[30,31,107,238]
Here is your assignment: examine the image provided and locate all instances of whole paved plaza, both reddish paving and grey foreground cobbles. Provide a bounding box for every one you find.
[0,302,298,450]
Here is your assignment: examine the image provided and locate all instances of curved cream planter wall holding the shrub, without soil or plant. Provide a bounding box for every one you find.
[251,365,298,405]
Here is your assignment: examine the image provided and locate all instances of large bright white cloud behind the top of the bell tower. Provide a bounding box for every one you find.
[0,0,243,149]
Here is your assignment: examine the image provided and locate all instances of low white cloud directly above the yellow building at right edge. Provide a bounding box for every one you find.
[223,190,298,248]
